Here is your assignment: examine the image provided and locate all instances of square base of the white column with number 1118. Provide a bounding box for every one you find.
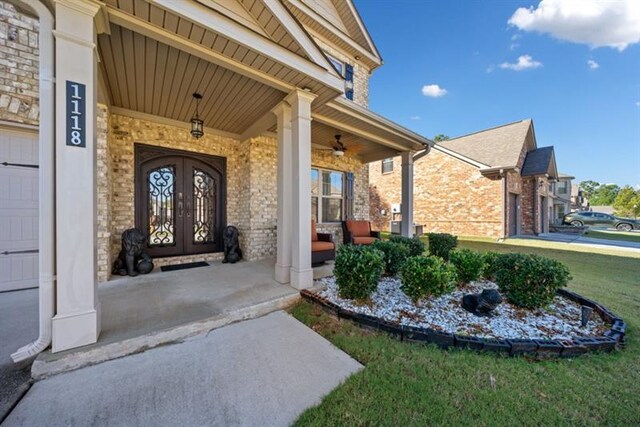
[51,309,100,353]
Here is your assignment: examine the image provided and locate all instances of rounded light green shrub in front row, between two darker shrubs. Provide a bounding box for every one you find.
[400,256,456,302]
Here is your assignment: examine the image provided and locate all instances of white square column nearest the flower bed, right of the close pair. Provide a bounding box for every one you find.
[286,90,316,289]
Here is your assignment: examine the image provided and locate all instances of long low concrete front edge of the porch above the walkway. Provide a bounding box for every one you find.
[31,292,300,380]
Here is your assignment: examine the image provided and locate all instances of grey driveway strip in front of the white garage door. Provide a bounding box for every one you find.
[0,289,38,420]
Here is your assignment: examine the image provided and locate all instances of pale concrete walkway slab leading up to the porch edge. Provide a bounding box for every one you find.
[5,311,361,427]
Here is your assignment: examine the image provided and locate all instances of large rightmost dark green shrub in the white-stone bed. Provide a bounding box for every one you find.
[496,254,571,309]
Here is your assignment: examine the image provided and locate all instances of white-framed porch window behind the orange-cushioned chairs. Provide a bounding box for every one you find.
[311,169,344,223]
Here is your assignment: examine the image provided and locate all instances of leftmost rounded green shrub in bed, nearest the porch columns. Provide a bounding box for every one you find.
[333,245,384,300]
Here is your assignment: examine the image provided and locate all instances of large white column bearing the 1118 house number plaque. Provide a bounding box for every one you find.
[52,0,100,352]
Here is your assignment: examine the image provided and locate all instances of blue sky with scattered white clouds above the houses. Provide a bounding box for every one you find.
[355,0,640,188]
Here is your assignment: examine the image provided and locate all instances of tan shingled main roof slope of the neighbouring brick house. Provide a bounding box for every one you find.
[436,119,536,168]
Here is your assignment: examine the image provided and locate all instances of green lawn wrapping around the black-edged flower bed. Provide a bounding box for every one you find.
[292,241,640,426]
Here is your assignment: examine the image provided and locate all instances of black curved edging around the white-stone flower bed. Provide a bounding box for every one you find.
[300,289,627,358]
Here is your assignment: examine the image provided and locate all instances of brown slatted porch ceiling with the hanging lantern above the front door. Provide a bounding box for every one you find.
[98,24,286,134]
